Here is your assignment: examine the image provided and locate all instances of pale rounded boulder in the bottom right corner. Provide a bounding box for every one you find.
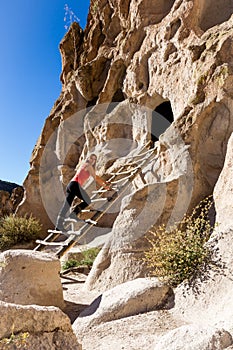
[154,324,233,350]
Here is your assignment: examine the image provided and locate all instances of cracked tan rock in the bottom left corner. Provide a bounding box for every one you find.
[0,301,82,350]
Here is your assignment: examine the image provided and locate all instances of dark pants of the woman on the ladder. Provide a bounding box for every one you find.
[56,181,91,228]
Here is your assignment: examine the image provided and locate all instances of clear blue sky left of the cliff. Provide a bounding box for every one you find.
[0,0,90,184]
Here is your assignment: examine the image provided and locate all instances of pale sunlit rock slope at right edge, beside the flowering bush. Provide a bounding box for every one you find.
[170,136,233,332]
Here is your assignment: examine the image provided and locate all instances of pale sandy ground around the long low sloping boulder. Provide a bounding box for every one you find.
[62,272,183,350]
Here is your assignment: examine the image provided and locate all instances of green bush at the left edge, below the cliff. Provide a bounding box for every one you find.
[0,214,42,250]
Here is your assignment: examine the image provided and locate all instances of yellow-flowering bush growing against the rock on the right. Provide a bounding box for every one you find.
[144,197,222,288]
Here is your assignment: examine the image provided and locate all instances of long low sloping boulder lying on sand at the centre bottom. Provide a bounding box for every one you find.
[73,278,173,335]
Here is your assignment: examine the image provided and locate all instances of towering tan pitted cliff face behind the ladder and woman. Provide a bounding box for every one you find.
[17,0,233,289]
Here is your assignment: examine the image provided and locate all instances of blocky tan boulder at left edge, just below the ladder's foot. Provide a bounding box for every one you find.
[0,249,65,309]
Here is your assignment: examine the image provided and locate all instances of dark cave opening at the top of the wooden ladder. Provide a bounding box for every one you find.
[151,101,174,143]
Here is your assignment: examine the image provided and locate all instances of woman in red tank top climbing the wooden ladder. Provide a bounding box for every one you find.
[55,154,110,231]
